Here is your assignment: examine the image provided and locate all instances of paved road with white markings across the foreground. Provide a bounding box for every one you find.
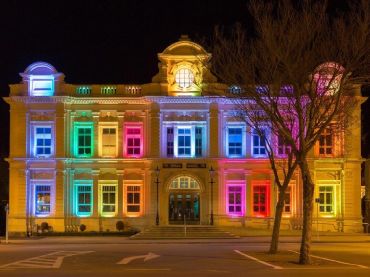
[0,238,370,277]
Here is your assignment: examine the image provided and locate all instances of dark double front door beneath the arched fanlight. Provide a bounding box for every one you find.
[168,190,200,224]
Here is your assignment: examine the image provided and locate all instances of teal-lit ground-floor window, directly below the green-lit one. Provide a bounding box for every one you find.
[75,182,93,216]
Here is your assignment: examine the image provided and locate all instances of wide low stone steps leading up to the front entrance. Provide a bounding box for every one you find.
[130,225,238,240]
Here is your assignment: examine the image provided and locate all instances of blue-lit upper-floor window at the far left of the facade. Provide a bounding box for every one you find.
[34,126,52,157]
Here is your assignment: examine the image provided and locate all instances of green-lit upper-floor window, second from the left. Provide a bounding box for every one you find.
[74,122,94,157]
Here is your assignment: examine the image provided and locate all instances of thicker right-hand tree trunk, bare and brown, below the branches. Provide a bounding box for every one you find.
[299,159,314,264]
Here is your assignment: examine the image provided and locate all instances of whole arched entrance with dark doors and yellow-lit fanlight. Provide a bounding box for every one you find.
[168,176,200,224]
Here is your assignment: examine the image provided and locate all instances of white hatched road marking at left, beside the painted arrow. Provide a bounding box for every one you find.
[0,251,94,270]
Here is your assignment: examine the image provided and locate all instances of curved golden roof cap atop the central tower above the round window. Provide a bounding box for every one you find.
[161,35,209,56]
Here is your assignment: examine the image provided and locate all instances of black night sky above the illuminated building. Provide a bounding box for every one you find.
[0,0,370,213]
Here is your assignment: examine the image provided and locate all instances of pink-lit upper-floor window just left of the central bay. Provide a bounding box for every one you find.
[124,126,143,157]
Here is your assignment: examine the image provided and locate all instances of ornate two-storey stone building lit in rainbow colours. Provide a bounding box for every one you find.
[5,36,362,233]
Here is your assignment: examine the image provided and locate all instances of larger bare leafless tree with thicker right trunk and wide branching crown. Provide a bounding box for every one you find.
[212,0,370,264]
